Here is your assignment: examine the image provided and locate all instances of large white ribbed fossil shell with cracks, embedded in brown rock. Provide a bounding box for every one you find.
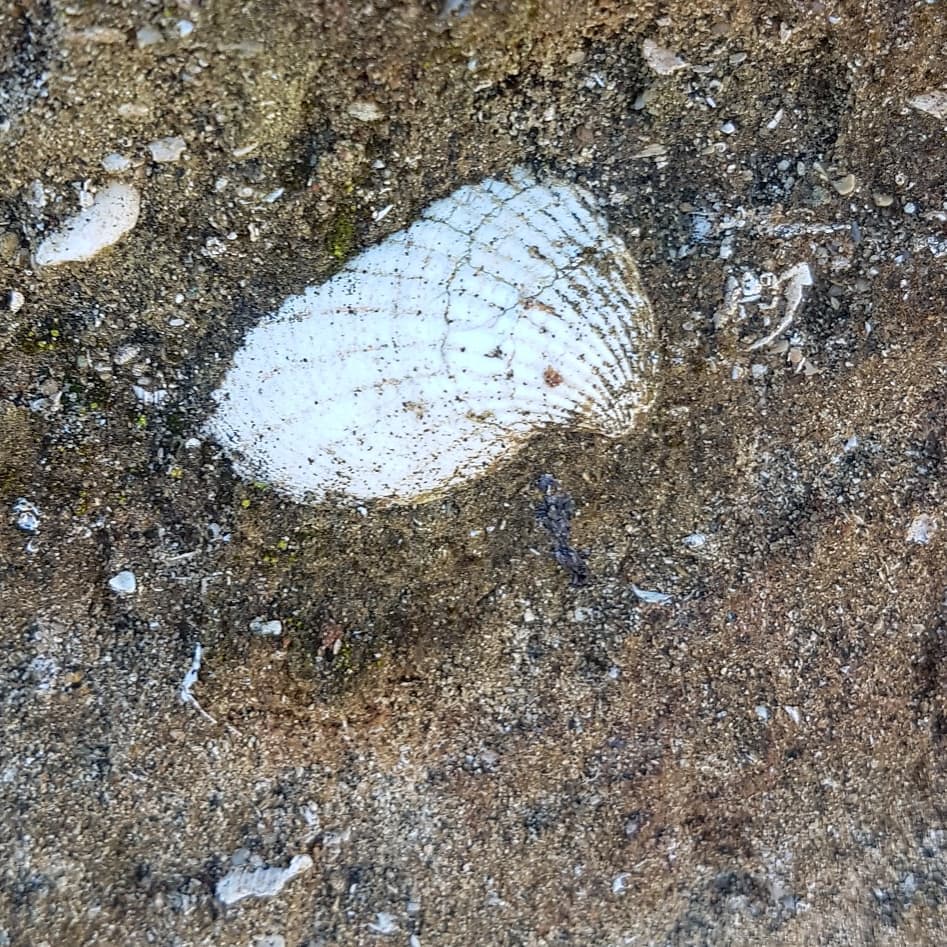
[207,170,654,503]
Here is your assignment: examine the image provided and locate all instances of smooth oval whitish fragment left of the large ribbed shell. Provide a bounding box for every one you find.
[34,183,141,266]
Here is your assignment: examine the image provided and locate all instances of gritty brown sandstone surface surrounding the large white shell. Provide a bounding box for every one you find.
[0,0,947,947]
